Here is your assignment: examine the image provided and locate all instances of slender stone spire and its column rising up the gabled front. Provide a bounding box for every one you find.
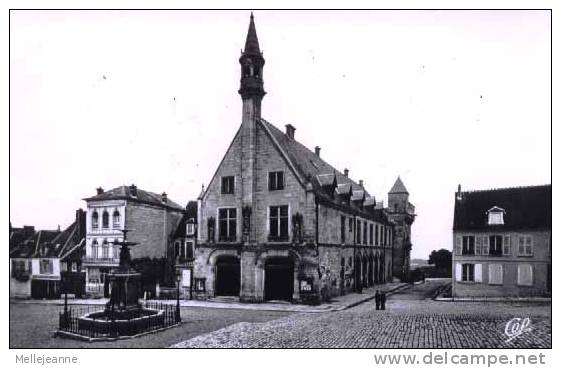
[238,13,266,244]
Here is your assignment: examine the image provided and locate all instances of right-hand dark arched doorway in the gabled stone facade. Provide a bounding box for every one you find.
[264,257,294,301]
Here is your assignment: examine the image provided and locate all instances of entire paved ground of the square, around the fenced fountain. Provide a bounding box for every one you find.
[10,281,551,348]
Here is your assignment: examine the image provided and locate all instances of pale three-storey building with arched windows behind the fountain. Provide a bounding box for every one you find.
[83,185,184,296]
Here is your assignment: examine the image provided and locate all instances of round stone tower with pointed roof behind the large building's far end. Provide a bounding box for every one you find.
[387,177,416,281]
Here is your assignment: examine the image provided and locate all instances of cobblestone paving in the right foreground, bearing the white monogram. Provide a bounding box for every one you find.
[175,281,551,348]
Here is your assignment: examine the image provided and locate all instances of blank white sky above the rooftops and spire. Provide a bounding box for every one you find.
[10,11,551,259]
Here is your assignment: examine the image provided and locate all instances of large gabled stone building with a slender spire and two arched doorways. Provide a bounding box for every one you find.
[193,15,413,304]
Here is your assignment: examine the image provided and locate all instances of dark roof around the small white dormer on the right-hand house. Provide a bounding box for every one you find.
[454,185,552,230]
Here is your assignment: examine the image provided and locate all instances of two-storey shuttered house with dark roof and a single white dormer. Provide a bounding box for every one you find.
[452,185,552,297]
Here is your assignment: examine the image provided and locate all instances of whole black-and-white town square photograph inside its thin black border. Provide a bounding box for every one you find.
[5,9,554,360]
